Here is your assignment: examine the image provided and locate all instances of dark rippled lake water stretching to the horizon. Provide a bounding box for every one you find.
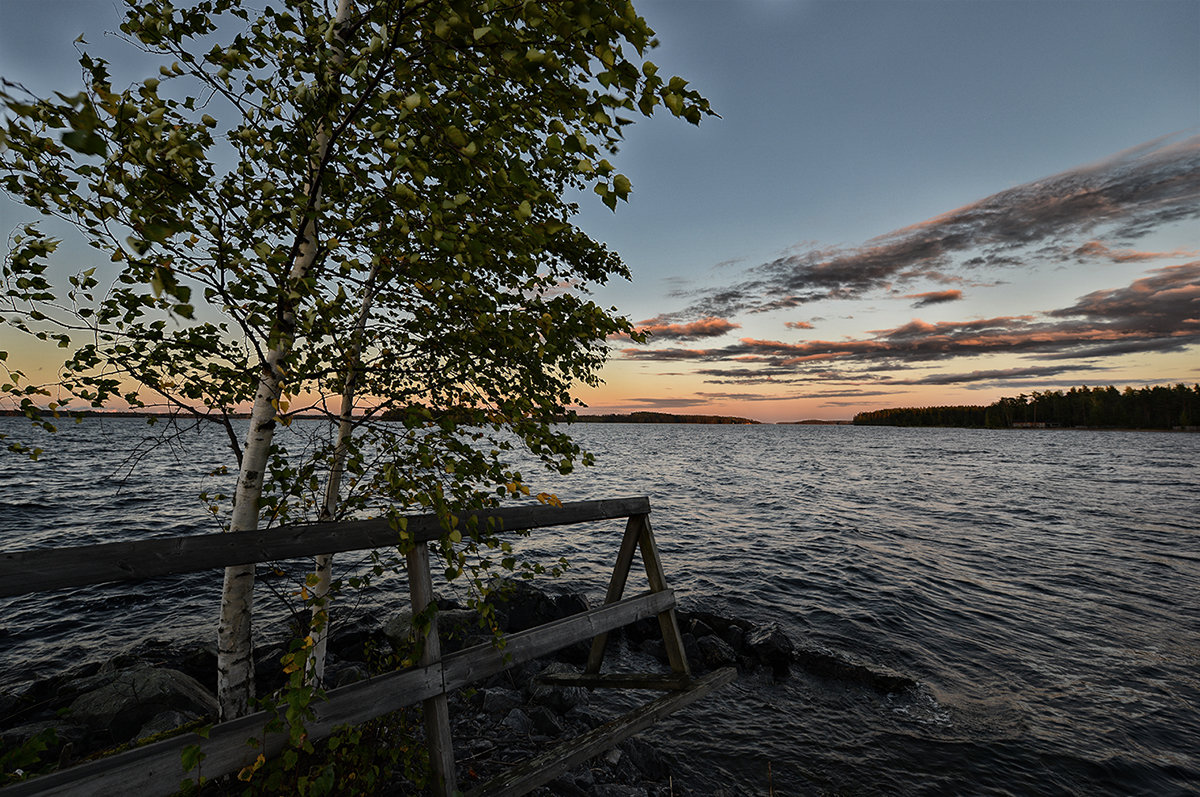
[0,419,1200,795]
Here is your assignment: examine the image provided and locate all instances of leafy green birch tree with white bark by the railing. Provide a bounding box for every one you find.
[0,0,710,718]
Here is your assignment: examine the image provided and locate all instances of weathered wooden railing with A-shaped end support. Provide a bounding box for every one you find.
[0,498,737,797]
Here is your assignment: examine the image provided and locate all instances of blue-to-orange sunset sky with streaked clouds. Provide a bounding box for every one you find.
[0,0,1200,421]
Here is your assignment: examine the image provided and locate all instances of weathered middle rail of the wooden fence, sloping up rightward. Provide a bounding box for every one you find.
[0,589,674,797]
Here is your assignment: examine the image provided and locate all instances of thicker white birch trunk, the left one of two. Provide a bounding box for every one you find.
[217,0,352,720]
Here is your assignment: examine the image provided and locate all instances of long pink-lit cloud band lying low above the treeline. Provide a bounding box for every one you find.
[623,260,1200,380]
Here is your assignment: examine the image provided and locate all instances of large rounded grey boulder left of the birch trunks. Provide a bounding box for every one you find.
[67,666,217,741]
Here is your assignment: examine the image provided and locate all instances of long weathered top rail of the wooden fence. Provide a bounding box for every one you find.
[0,497,650,597]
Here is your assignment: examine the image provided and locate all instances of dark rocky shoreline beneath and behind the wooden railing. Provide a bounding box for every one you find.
[0,581,816,797]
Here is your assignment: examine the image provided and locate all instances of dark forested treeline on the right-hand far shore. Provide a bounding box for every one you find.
[854,384,1200,429]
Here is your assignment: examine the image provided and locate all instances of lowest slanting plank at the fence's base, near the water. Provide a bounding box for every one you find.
[467,667,738,797]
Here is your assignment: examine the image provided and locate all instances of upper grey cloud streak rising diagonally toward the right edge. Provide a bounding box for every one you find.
[671,136,1200,319]
